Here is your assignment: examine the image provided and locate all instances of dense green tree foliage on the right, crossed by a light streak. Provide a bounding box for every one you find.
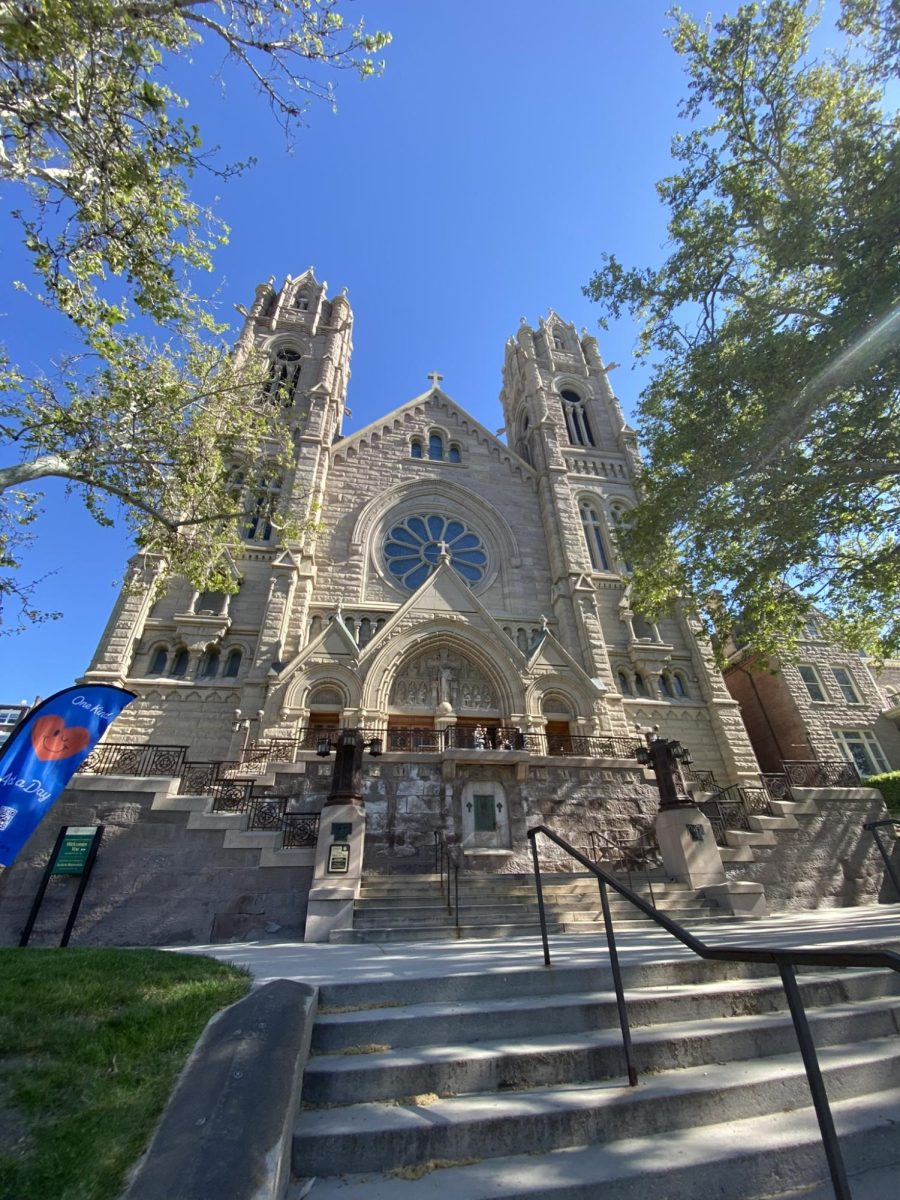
[586,0,900,654]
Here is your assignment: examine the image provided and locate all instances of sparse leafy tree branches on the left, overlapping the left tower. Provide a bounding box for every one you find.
[0,0,390,629]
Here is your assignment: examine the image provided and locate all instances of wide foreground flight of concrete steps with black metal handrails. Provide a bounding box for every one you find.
[288,947,900,1200]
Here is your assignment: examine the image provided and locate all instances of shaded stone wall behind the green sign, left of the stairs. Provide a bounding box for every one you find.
[0,779,312,946]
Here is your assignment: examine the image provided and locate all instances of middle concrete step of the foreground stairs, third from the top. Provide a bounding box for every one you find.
[304,997,900,1108]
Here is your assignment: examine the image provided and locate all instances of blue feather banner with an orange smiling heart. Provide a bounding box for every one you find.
[0,684,134,866]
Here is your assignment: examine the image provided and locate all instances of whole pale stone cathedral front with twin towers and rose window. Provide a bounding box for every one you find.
[85,270,758,868]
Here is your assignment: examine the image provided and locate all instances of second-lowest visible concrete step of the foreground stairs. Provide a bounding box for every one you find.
[293,1038,900,1176]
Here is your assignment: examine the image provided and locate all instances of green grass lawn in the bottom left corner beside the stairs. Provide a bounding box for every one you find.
[0,948,250,1200]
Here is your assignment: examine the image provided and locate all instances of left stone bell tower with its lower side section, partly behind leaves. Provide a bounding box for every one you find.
[84,276,353,754]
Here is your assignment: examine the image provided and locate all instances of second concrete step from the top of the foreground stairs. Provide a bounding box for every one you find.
[312,971,900,1054]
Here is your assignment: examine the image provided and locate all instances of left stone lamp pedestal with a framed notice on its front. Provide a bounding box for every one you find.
[304,803,366,942]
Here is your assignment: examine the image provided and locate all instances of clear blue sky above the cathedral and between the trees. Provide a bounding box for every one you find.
[0,0,844,702]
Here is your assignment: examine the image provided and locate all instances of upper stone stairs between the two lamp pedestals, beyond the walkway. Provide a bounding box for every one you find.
[331,869,734,942]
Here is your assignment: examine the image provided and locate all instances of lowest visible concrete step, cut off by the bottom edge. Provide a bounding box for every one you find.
[286,1085,900,1200]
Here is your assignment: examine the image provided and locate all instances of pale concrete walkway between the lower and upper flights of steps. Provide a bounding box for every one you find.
[164,905,900,984]
